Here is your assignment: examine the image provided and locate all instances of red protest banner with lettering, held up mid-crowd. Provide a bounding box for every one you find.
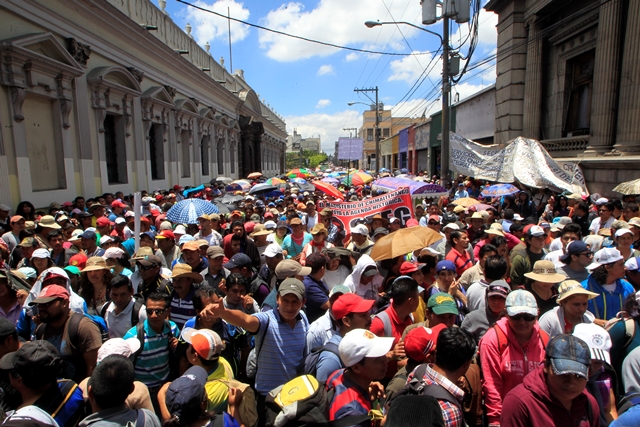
[318,188,413,242]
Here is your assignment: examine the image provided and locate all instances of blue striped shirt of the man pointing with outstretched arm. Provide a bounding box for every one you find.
[253,309,309,395]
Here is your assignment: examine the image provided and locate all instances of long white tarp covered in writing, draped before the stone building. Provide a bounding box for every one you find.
[450,133,589,194]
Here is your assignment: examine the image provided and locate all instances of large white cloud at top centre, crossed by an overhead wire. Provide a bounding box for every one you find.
[259,0,430,62]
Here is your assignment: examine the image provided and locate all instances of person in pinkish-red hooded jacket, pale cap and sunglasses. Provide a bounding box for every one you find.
[480,289,549,425]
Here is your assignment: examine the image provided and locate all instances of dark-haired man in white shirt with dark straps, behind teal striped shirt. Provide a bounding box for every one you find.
[100,274,147,338]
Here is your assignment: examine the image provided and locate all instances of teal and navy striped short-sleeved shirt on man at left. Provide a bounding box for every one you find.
[123,320,180,388]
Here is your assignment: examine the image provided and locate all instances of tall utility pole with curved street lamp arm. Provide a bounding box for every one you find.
[364,10,451,185]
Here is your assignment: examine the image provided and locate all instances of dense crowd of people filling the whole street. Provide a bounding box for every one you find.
[0,172,640,427]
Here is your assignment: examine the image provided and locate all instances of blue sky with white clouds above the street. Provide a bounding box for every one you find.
[158,0,498,154]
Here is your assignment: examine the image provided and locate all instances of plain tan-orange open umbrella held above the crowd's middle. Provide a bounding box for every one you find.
[371,227,442,261]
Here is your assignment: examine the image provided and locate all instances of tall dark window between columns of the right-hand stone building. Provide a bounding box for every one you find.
[564,50,595,136]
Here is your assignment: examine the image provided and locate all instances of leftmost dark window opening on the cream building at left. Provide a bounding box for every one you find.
[104,114,127,184]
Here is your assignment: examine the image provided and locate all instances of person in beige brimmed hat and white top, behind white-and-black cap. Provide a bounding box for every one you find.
[539,280,598,338]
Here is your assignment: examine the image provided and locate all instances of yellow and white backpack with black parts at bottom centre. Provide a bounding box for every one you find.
[265,375,371,427]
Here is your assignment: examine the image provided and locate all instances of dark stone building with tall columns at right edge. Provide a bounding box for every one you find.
[485,0,640,197]
